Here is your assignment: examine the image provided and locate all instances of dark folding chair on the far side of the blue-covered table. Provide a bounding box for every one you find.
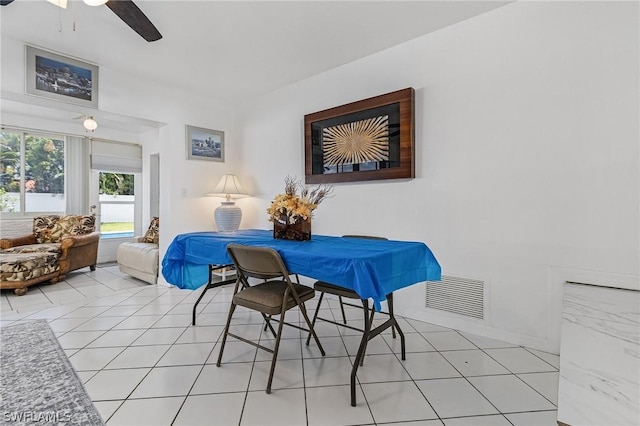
[307,235,405,365]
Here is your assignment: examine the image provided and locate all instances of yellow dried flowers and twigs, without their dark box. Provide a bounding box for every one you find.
[267,176,333,224]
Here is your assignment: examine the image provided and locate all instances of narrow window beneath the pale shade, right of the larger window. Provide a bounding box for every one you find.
[98,172,136,238]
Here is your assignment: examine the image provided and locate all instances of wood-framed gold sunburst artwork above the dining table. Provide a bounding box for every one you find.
[304,88,415,183]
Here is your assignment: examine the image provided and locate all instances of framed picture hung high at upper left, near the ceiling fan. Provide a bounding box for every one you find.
[25,45,98,108]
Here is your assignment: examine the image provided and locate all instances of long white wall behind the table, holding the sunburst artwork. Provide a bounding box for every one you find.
[241,2,640,352]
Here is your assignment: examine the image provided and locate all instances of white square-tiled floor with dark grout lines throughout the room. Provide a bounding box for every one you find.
[0,265,559,426]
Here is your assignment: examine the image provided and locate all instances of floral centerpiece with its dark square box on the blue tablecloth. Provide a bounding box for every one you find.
[267,176,333,240]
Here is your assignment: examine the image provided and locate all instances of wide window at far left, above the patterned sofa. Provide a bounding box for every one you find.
[0,130,66,215]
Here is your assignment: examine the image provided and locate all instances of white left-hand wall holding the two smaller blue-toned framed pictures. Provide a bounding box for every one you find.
[2,35,240,272]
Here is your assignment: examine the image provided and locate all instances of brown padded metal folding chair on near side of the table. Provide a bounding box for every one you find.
[216,244,325,394]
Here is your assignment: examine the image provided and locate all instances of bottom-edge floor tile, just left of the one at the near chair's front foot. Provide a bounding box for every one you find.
[173,392,245,426]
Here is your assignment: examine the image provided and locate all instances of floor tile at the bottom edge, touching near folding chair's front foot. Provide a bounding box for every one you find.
[240,389,307,426]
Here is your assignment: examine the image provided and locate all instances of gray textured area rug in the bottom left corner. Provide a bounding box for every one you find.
[0,320,104,425]
